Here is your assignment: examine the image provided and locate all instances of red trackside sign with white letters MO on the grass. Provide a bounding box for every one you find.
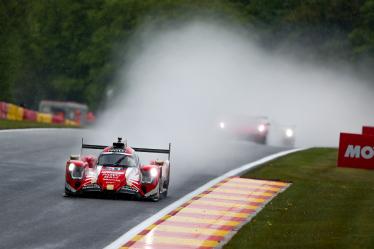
[338,133,374,169]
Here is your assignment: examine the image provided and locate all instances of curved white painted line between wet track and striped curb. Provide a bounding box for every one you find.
[104,149,305,249]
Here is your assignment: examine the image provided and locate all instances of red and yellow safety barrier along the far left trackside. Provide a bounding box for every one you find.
[0,102,79,126]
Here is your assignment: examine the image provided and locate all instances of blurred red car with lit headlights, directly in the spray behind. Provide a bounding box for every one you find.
[218,116,270,144]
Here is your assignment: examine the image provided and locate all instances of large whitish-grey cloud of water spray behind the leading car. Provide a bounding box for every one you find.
[93,22,374,147]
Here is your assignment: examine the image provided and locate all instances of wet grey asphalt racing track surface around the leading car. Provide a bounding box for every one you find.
[0,130,282,248]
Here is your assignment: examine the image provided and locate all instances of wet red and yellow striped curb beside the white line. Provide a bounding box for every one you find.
[121,177,290,249]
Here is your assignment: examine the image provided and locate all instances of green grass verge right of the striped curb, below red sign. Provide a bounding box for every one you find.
[224,148,374,249]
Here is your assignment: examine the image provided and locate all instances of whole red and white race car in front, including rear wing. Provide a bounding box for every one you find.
[65,138,170,201]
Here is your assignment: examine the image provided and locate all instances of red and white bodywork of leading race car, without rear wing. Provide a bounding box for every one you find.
[65,143,170,200]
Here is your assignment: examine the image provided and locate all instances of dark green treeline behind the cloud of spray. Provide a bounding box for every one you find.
[0,0,374,110]
